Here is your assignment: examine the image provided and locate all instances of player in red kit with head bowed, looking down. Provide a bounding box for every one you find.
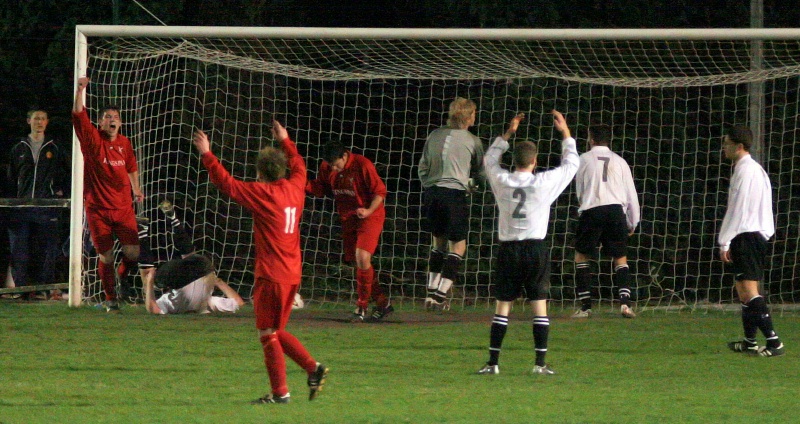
[306,141,394,322]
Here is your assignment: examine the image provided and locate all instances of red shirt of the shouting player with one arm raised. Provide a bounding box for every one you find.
[72,109,139,209]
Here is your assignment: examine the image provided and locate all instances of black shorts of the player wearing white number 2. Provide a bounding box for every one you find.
[493,240,550,302]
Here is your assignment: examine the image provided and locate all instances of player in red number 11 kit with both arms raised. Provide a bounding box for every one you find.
[194,121,328,404]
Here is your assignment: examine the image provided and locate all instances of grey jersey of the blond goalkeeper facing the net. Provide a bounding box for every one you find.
[418,127,483,190]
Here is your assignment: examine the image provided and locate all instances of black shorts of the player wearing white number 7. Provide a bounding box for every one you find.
[575,205,629,258]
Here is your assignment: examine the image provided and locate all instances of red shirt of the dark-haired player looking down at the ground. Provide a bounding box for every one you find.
[306,152,386,220]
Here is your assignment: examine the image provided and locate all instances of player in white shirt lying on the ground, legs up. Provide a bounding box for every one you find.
[134,200,244,314]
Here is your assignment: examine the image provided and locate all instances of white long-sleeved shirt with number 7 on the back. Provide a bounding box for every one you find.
[575,146,641,231]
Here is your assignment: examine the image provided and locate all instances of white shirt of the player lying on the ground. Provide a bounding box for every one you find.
[156,273,239,314]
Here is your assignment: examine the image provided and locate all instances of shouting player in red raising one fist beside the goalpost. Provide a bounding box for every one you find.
[72,77,144,312]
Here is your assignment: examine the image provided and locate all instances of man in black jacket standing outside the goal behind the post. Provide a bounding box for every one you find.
[8,109,70,298]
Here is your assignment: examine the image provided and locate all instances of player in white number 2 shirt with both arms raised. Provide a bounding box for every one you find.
[478,110,578,375]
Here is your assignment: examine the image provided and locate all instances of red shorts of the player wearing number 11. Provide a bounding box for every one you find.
[253,278,300,331]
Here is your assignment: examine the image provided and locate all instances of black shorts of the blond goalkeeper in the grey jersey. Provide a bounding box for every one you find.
[422,186,469,242]
